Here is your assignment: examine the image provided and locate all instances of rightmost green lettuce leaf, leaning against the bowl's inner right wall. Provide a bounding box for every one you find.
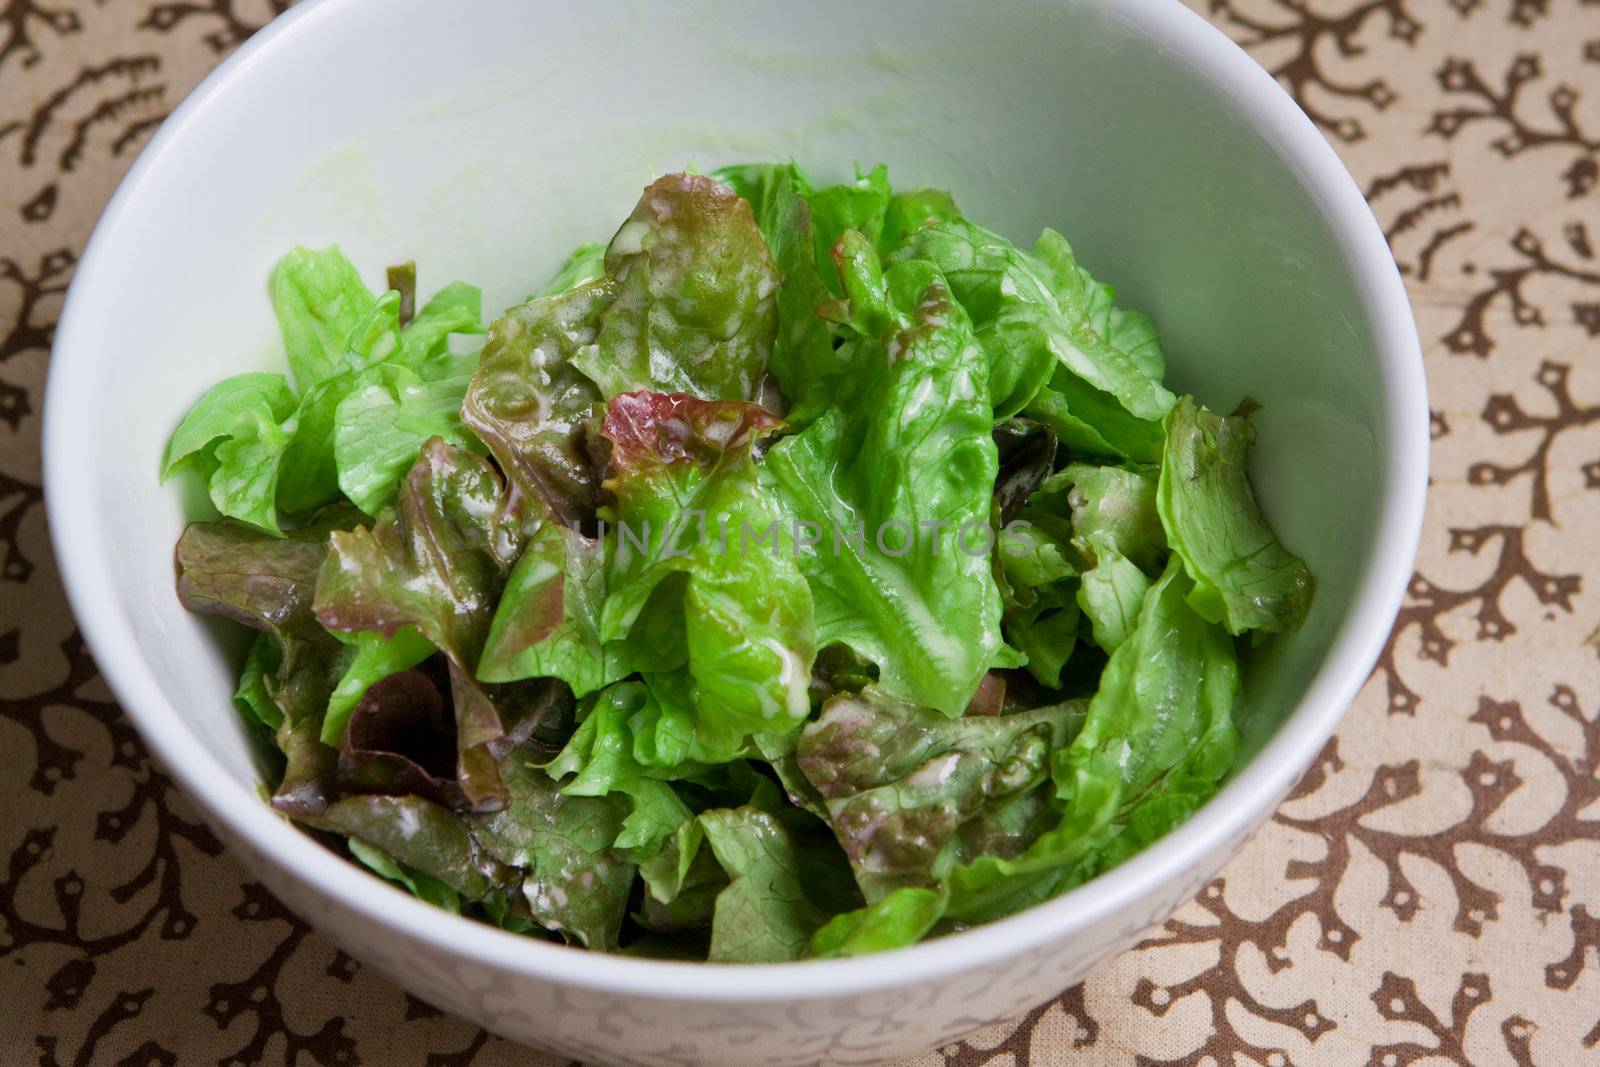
[1157,397,1312,633]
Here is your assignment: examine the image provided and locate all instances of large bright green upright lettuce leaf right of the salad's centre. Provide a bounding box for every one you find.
[763,266,1002,715]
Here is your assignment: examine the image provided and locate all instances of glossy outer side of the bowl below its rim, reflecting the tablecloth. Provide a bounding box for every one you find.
[208,790,1270,1067]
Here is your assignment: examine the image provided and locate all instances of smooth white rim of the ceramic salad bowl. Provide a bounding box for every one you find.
[43,0,1429,1003]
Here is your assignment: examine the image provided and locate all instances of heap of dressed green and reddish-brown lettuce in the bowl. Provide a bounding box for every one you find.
[165,165,1312,961]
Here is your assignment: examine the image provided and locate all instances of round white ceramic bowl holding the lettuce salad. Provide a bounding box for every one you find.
[45,0,1427,1064]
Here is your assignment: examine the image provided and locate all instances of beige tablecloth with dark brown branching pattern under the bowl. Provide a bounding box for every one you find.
[0,0,1600,1067]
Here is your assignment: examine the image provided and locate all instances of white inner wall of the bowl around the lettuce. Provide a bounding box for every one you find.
[51,0,1392,915]
